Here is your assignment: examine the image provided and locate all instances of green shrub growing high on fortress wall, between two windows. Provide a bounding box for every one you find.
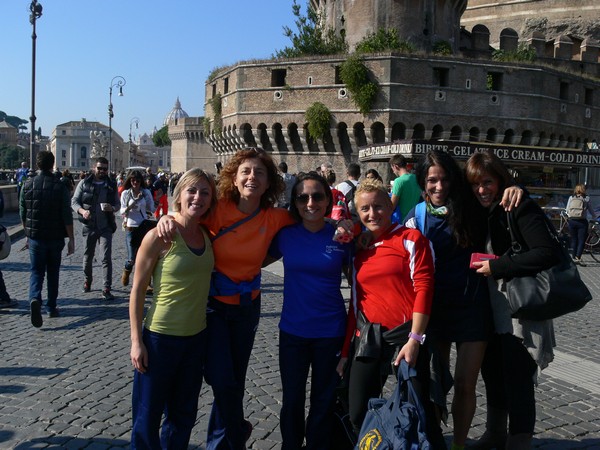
[340,55,379,116]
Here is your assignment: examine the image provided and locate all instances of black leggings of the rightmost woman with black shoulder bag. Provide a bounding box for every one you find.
[481,333,537,434]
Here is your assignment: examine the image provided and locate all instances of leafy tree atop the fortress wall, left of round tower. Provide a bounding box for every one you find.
[275,0,348,58]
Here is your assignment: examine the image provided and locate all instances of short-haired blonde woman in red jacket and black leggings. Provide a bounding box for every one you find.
[338,180,446,449]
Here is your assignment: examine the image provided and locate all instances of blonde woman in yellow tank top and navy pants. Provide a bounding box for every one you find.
[129,169,216,449]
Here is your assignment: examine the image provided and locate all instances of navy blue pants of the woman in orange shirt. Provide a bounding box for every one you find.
[205,295,260,450]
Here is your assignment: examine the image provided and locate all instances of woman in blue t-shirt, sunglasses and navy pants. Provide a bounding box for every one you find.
[269,172,351,450]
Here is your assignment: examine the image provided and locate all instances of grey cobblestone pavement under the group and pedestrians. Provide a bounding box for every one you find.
[0,213,600,450]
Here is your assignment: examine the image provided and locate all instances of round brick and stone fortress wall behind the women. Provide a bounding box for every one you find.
[169,0,600,178]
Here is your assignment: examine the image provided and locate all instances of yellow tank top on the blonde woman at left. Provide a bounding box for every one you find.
[144,229,215,336]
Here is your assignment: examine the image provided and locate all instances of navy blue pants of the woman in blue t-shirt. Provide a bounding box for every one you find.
[279,331,344,450]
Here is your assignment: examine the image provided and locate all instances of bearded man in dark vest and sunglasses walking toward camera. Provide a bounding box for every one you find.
[71,157,121,300]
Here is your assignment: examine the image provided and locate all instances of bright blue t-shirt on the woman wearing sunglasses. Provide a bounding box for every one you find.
[269,223,352,338]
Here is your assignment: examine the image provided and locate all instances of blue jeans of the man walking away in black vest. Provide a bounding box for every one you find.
[29,239,65,310]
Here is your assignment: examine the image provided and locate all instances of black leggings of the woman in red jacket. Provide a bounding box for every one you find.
[348,344,446,450]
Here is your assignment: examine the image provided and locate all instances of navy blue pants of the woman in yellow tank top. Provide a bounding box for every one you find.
[131,329,207,449]
